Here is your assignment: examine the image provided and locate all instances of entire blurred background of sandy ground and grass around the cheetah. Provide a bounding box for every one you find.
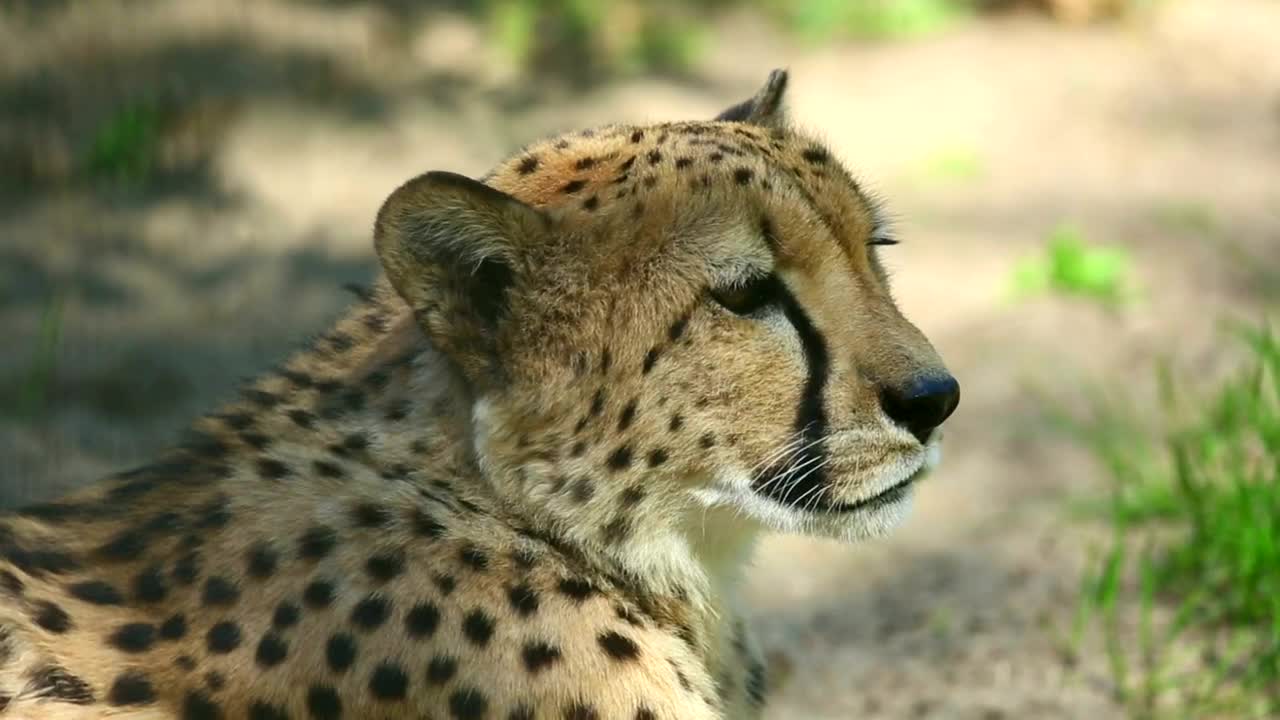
[0,0,1280,720]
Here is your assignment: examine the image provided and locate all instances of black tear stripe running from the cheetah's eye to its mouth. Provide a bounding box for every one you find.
[755,271,831,507]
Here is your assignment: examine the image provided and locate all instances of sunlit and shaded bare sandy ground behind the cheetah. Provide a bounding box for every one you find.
[0,0,1280,720]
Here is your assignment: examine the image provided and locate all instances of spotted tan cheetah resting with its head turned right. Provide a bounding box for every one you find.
[0,70,959,720]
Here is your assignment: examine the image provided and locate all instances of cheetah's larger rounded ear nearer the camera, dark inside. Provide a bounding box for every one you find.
[374,172,548,386]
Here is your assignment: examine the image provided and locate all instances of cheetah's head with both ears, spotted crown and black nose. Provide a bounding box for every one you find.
[375,72,959,543]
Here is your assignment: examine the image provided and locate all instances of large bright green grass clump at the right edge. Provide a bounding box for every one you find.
[1078,324,1280,717]
